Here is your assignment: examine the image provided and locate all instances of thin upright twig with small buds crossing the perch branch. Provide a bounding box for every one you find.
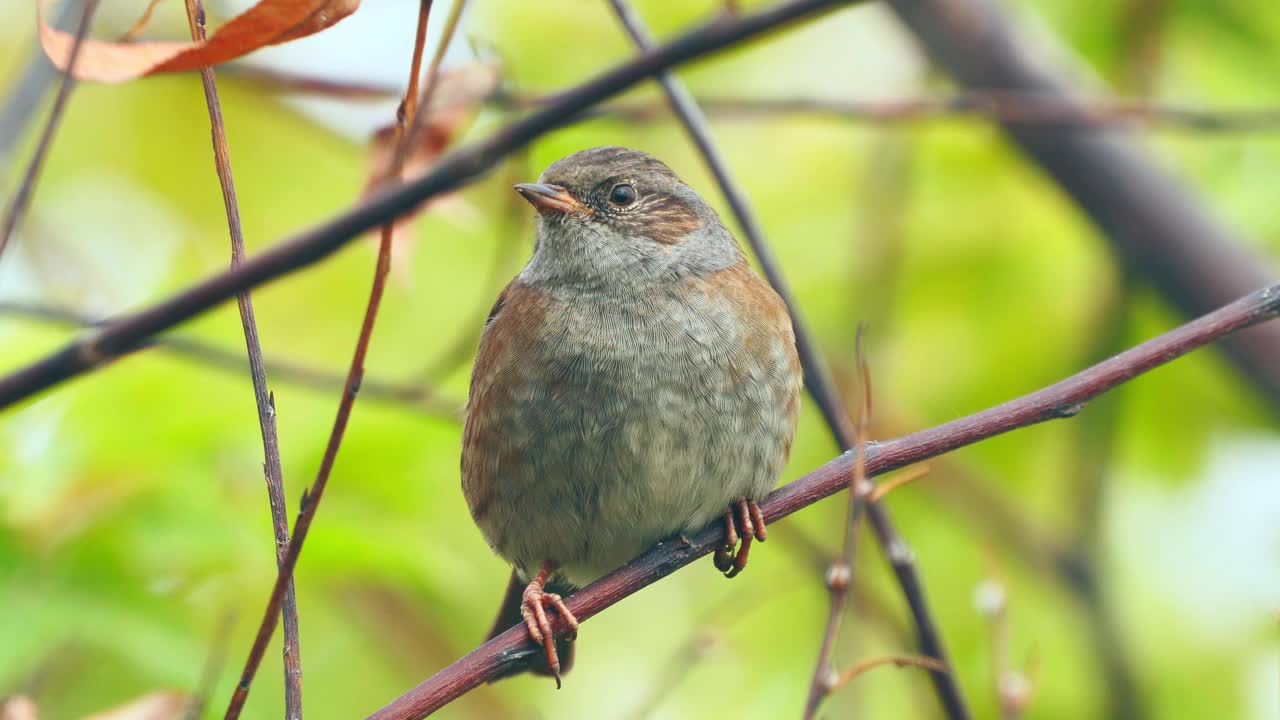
[804,325,875,720]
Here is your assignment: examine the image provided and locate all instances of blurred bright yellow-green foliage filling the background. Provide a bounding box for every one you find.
[0,0,1280,719]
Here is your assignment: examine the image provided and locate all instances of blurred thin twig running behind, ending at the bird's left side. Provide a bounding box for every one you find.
[0,300,462,415]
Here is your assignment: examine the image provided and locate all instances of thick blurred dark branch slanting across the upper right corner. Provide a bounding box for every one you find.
[888,0,1280,411]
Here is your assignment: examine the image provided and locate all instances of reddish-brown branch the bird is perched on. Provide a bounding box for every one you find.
[370,284,1280,720]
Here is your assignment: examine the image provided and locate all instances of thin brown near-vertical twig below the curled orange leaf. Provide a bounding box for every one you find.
[181,0,302,720]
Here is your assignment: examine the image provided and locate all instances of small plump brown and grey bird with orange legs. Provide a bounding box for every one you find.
[462,147,801,685]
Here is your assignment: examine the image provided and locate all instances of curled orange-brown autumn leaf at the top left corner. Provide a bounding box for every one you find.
[36,0,360,82]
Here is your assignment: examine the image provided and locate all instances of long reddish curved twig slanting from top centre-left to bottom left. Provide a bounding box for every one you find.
[227,0,451,720]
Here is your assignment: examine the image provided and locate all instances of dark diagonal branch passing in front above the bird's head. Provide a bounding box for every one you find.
[0,0,851,409]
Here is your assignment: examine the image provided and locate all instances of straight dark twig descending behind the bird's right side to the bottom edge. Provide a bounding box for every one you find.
[611,0,969,720]
